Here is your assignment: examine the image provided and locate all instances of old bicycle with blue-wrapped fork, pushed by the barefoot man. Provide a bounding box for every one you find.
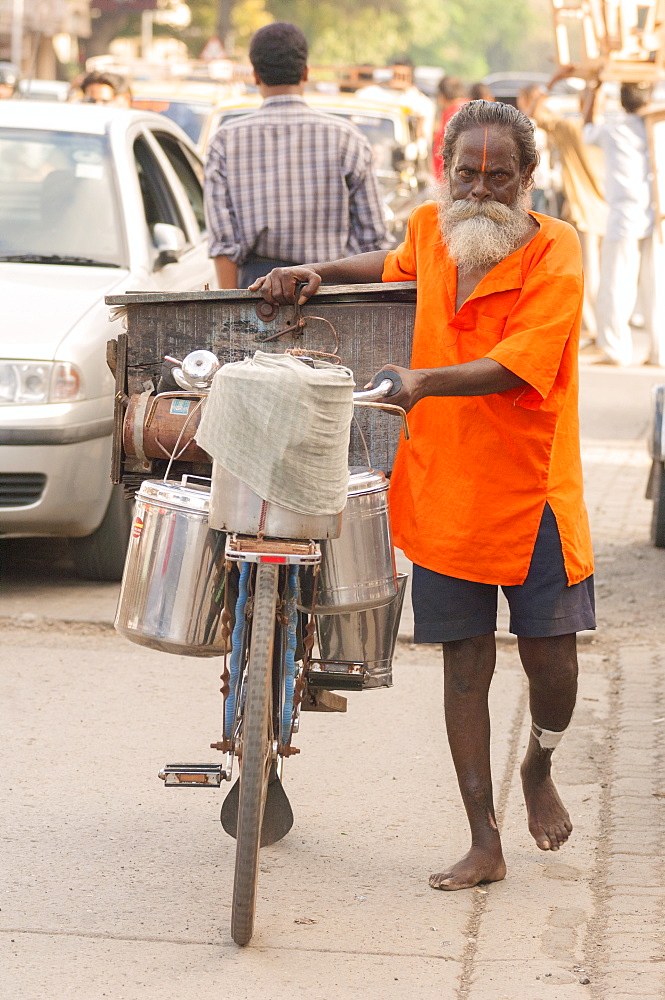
[116,351,408,946]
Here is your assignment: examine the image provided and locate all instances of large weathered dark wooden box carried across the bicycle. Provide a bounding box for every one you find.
[106,282,416,491]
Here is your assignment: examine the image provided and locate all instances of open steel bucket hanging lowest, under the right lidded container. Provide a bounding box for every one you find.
[316,573,408,689]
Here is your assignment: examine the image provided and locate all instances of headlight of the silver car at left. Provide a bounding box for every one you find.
[0,361,83,405]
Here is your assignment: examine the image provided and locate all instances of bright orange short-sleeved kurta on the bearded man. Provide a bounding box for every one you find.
[383,202,593,586]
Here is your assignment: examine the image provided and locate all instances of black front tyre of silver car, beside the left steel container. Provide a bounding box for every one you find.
[69,486,134,580]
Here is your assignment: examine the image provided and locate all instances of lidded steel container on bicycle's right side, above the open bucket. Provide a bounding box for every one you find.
[300,469,397,615]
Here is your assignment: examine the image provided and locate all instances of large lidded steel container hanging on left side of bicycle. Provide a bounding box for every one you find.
[115,476,225,656]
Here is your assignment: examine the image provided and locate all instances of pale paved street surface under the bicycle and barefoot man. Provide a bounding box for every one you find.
[0,364,665,1000]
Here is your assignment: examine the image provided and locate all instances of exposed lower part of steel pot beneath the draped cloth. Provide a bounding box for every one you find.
[210,462,342,541]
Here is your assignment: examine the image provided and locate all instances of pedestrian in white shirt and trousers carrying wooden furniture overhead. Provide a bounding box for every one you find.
[583,83,665,365]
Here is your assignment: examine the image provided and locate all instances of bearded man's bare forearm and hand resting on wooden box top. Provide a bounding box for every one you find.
[249,250,388,305]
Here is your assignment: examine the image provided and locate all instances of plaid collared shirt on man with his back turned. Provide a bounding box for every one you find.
[205,95,392,264]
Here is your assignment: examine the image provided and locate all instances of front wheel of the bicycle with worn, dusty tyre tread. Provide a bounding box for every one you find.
[231,563,279,945]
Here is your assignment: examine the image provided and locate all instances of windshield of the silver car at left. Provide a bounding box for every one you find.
[0,128,124,267]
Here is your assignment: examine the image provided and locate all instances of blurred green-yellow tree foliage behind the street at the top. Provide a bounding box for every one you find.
[87,0,553,80]
